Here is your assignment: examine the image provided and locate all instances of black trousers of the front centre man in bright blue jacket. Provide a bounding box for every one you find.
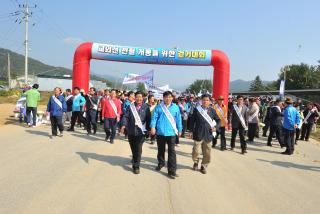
[157,135,177,173]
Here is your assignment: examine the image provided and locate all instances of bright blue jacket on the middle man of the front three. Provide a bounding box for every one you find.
[150,103,182,136]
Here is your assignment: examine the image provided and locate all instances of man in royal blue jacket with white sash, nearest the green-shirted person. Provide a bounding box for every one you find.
[47,87,67,137]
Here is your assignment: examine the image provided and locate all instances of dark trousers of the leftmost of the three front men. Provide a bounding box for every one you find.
[128,135,144,169]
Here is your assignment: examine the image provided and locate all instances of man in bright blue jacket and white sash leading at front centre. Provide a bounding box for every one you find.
[150,91,182,179]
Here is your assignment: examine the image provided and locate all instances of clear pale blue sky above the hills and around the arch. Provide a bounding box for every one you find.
[0,0,320,88]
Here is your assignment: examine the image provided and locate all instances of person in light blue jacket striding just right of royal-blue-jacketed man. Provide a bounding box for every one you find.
[67,87,87,131]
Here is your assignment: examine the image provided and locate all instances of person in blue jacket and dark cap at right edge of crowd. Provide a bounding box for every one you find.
[281,97,300,155]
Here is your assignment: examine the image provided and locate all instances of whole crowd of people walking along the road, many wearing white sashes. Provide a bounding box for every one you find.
[23,84,319,179]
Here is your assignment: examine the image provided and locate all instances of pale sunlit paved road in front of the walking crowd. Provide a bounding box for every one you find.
[0,121,320,214]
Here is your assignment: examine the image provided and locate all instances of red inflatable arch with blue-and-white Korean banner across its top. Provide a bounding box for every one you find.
[72,42,230,99]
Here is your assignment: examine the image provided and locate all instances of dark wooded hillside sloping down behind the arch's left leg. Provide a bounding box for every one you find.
[0,48,105,81]
